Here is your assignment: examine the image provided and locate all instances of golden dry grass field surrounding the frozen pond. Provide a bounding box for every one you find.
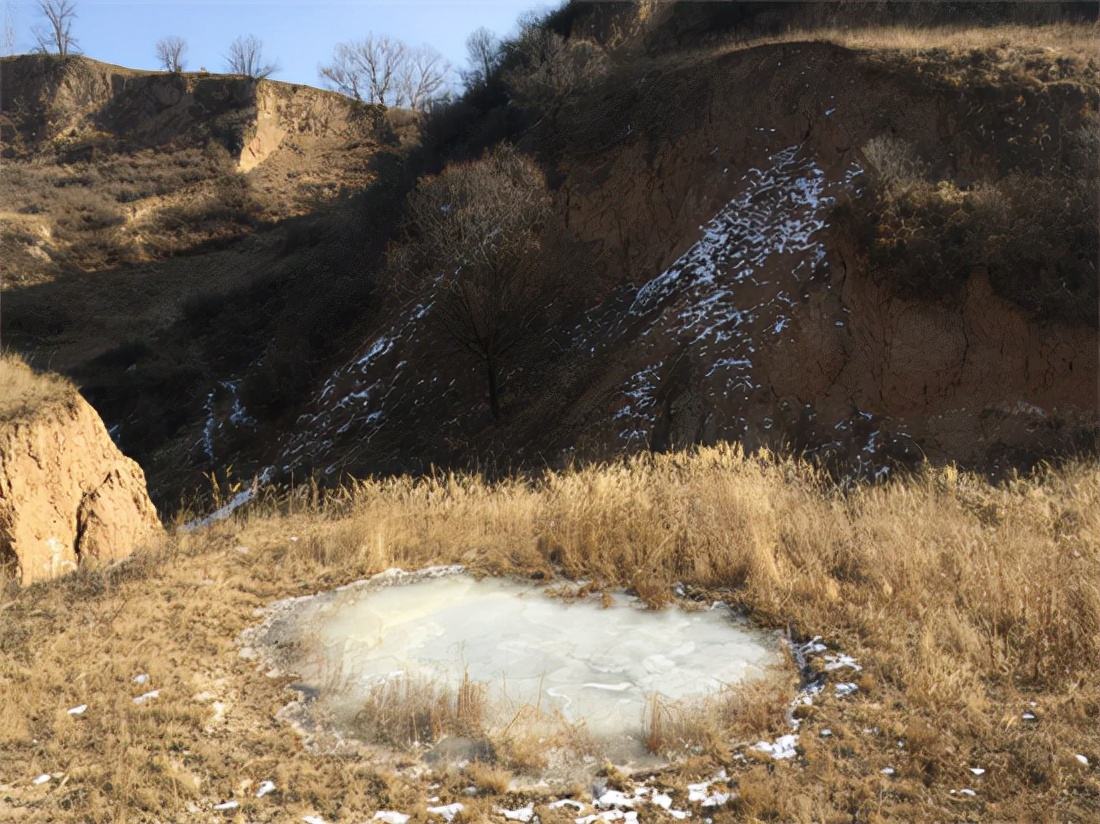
[0,448,1100,821]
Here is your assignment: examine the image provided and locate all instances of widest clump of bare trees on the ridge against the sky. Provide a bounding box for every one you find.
[318,34,449,109]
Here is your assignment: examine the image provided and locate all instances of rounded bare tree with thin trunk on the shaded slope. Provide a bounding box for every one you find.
[388,147,561,420]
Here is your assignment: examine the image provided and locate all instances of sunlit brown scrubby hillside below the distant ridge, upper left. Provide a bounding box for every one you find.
[0,55,398,286]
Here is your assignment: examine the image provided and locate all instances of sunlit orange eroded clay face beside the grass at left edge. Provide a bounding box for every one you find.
[0,391,163,585]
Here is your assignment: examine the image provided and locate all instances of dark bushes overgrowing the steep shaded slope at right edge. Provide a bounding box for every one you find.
[834,118,1100,326]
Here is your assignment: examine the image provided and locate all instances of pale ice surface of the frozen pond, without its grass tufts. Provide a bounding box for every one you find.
[245,571,780,765]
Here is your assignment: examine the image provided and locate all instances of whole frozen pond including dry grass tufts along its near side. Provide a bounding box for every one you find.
[242,568,782,766]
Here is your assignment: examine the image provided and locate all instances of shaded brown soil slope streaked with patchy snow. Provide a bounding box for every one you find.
[255,43,1098,486]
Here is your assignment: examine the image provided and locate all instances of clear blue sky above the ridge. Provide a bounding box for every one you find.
[0,0,561,86]
